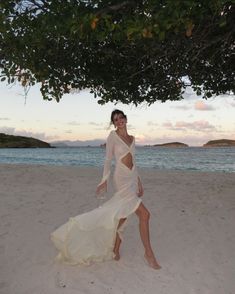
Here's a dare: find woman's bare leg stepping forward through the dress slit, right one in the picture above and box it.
[135,203,161,269]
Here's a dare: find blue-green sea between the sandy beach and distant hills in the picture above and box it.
[0,147,235,172]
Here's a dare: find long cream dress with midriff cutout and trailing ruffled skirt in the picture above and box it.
[51,131,141,265]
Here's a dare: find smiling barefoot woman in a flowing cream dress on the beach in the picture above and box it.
[51,109,161,269]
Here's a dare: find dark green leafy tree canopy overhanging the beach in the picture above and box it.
[0,0,235,105]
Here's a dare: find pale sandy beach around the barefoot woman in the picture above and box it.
[0,164,235,294]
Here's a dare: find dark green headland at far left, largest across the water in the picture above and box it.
[0,133,51,148]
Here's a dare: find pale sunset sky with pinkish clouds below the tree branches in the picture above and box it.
[0,82,235,146]
